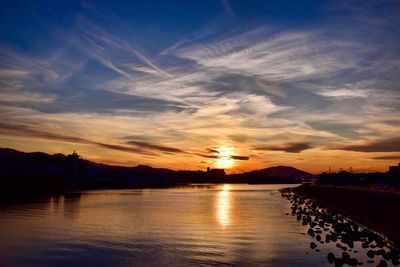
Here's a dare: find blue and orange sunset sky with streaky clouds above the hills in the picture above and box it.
[0,0,400,173]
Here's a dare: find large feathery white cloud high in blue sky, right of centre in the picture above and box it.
[176,28,360,81]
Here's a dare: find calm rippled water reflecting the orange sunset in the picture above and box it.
[0,185,364,266]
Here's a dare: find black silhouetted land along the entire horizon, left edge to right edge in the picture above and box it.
[0,148,400,198]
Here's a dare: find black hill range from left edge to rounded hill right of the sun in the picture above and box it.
[0,148,314,192]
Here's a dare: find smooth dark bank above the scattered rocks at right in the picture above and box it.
[293,185,400,243]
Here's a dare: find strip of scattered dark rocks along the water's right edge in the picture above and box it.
[281,188,400,267]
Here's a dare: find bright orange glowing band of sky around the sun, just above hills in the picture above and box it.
[0,135,398,174]
